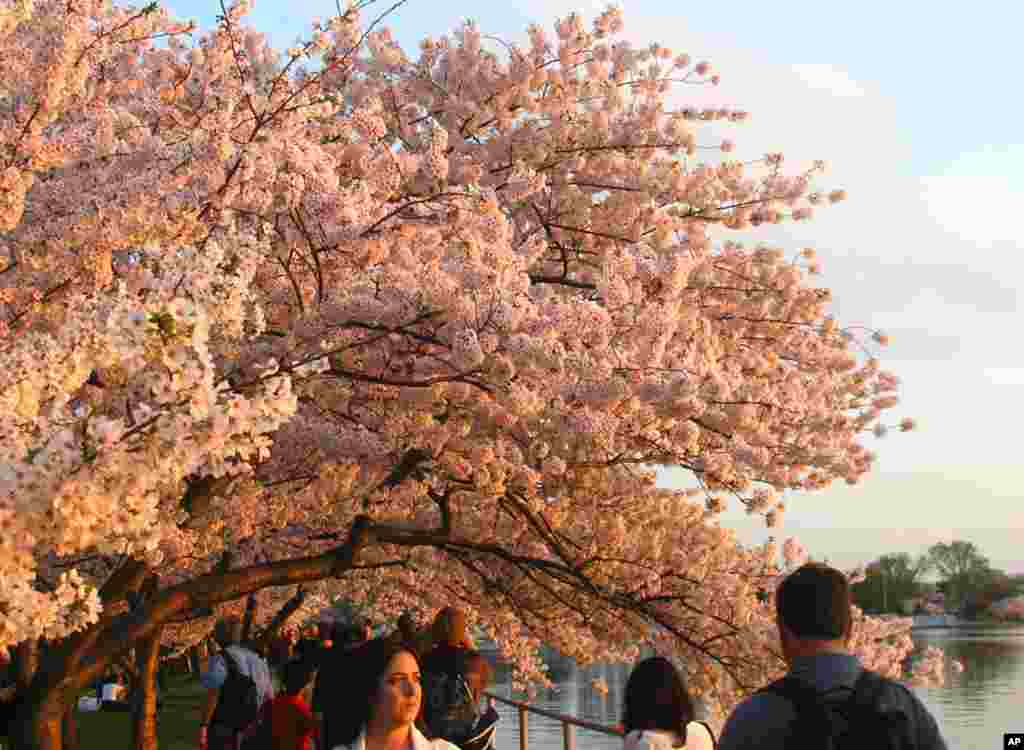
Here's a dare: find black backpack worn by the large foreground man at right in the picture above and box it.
[762,669,914,750]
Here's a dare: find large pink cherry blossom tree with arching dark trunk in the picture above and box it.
[0,0,937,750]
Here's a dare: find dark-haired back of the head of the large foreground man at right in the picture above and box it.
[775,563,853,662]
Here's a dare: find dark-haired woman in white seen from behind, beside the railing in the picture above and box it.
[623,657,715,750]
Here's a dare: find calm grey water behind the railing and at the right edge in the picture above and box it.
[495,626,1024,750]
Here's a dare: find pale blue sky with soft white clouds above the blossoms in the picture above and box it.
[163,0,1024,573]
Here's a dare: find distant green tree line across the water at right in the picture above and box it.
[852,540,1024,618]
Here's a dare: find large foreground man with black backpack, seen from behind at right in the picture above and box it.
[719,563,946,750]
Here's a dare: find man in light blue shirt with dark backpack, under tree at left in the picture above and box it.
[200,617,273,750]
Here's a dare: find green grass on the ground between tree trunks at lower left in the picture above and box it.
[75,675,206,750]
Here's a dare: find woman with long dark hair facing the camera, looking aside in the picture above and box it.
[327,638,459,750]
